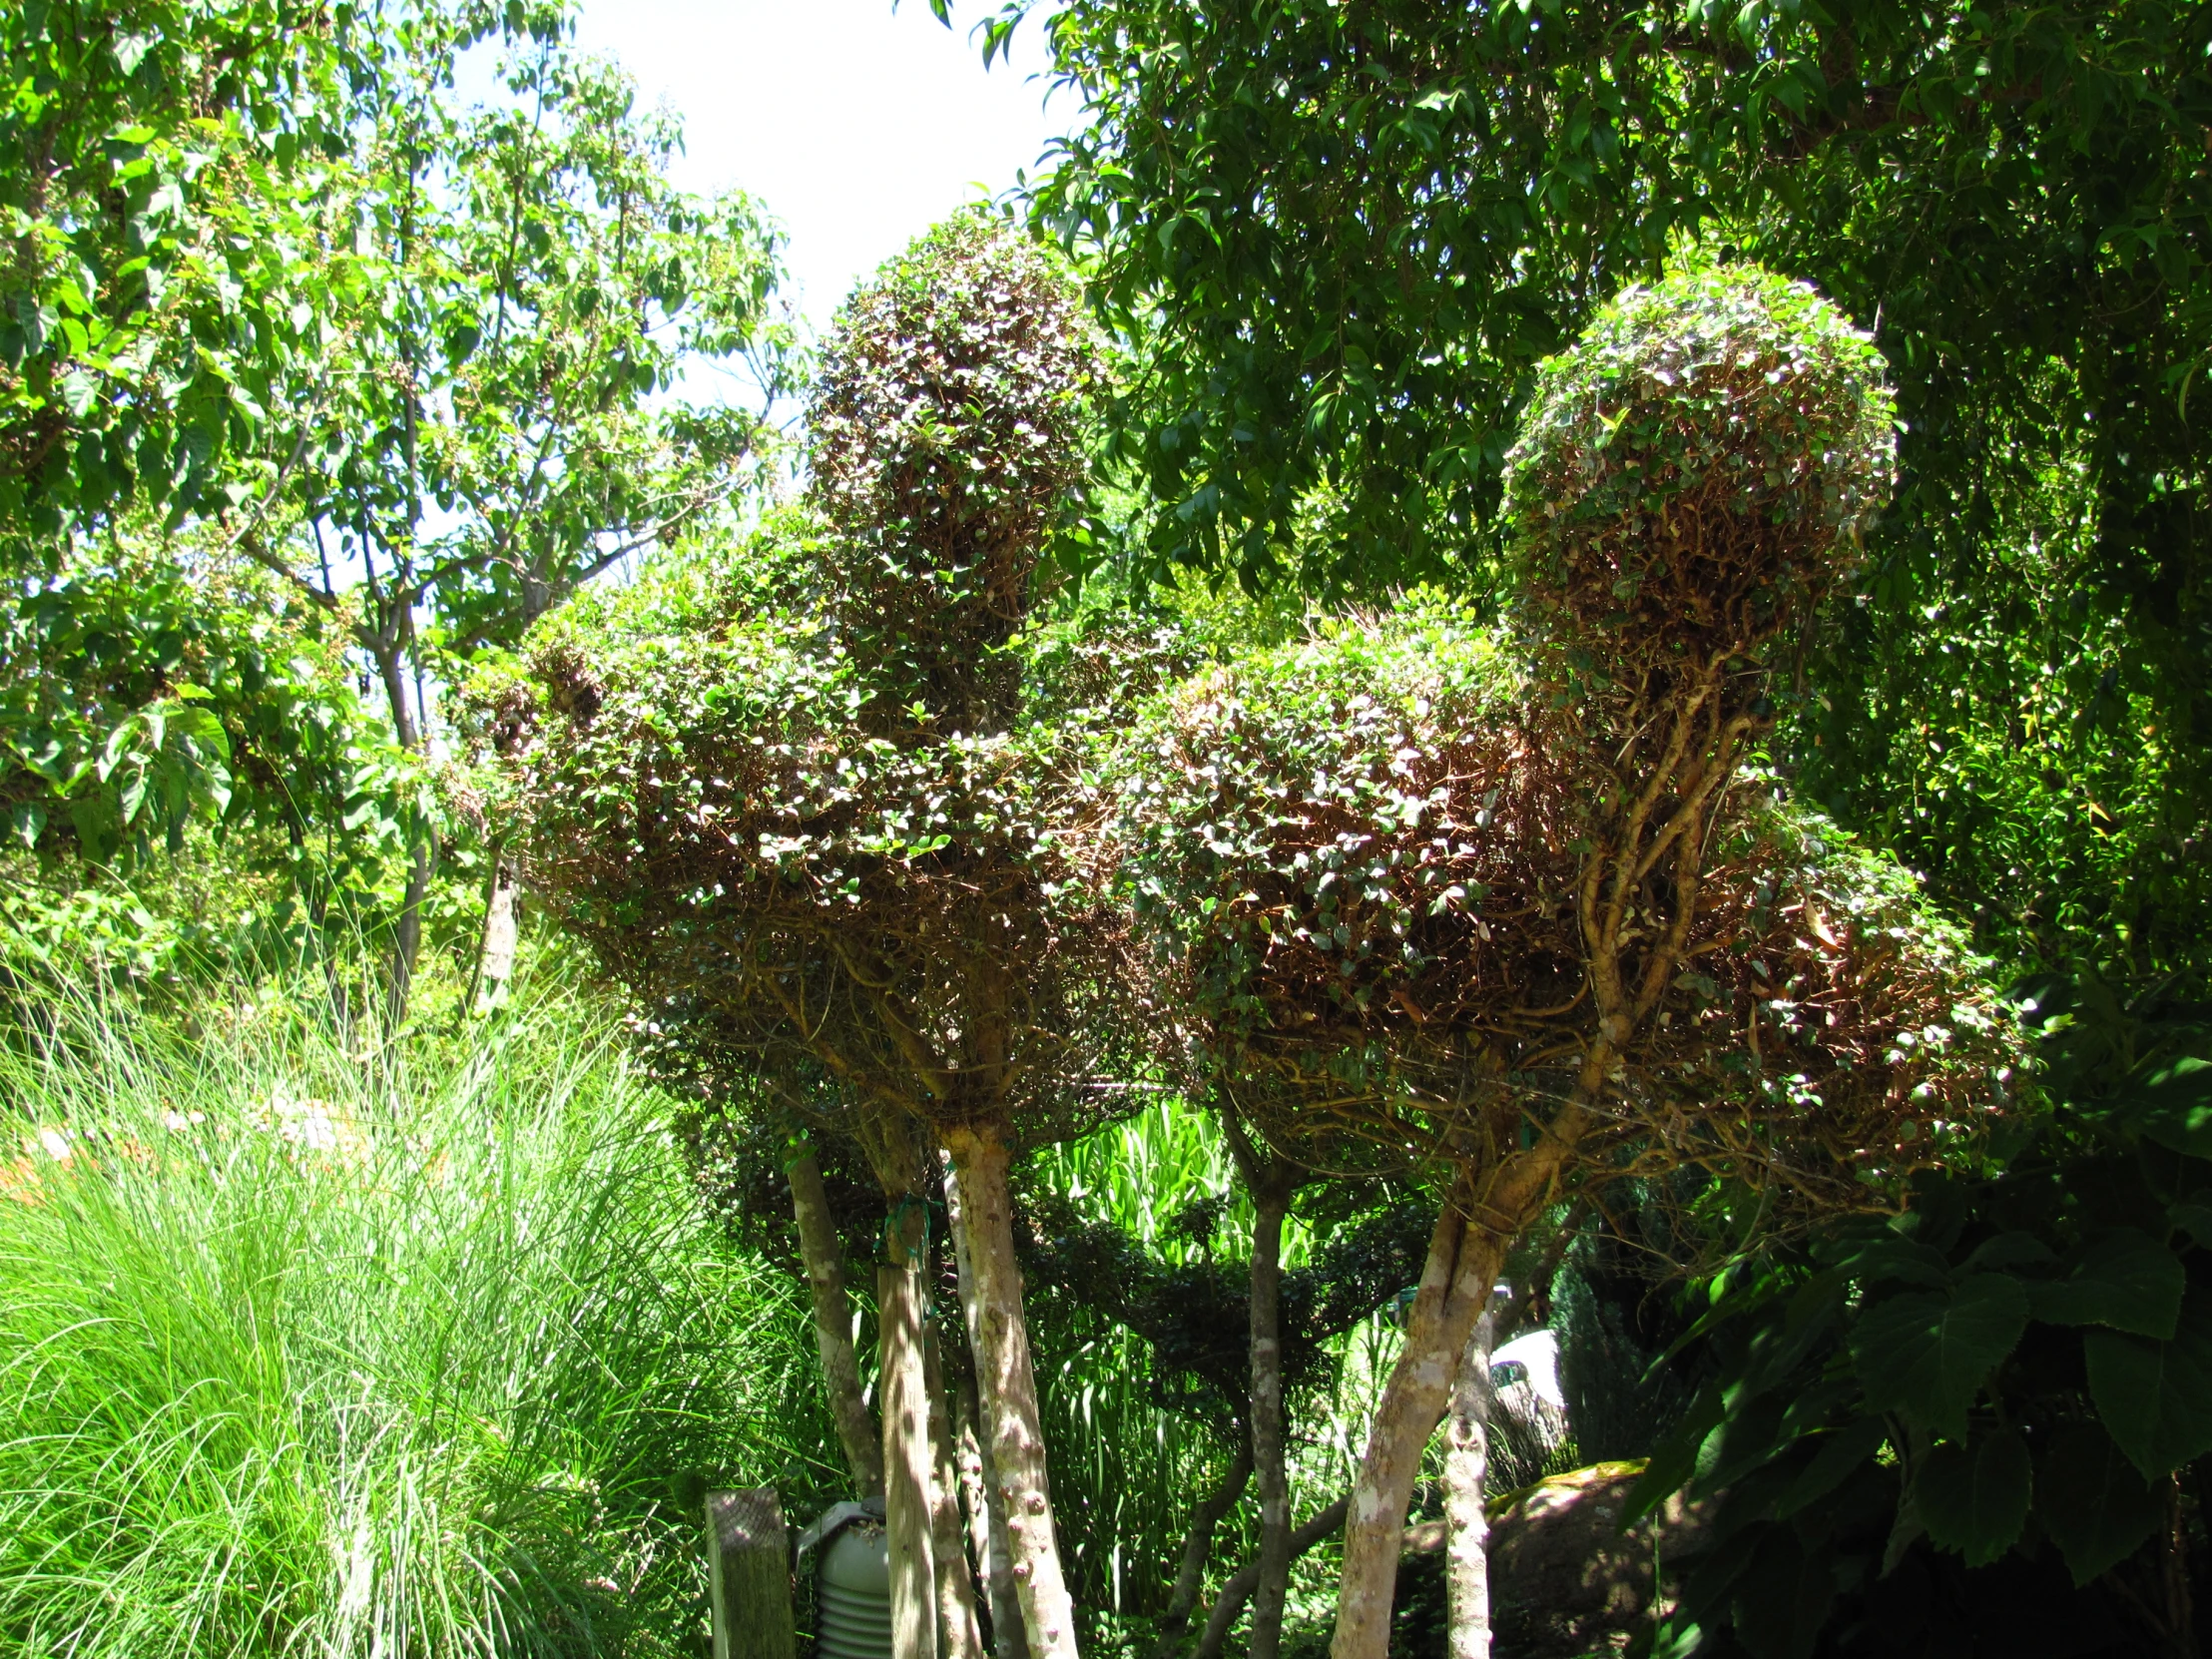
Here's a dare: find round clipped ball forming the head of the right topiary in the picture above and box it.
[1506,266,1896,668]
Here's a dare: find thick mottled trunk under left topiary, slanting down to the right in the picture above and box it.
[946,1128,1075,1659]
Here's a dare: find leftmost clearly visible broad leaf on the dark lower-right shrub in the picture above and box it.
[1852,1274,2028,1440]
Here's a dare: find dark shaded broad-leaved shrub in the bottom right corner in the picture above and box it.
[1639,986,2212,1655]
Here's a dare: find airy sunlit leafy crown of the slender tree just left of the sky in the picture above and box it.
[244,26,790,657]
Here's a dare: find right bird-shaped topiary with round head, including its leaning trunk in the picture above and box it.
[1115,268,2010,1659]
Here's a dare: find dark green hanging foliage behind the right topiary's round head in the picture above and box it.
[977,0,2212,1026]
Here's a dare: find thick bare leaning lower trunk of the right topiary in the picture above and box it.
[1330,1204,1504,1659]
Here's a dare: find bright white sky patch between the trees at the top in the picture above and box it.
[577,0,1079,331]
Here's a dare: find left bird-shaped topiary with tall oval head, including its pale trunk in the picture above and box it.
[475,219,1126,1659]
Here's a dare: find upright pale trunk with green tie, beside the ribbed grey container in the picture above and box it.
[876,1199,938,1659]
